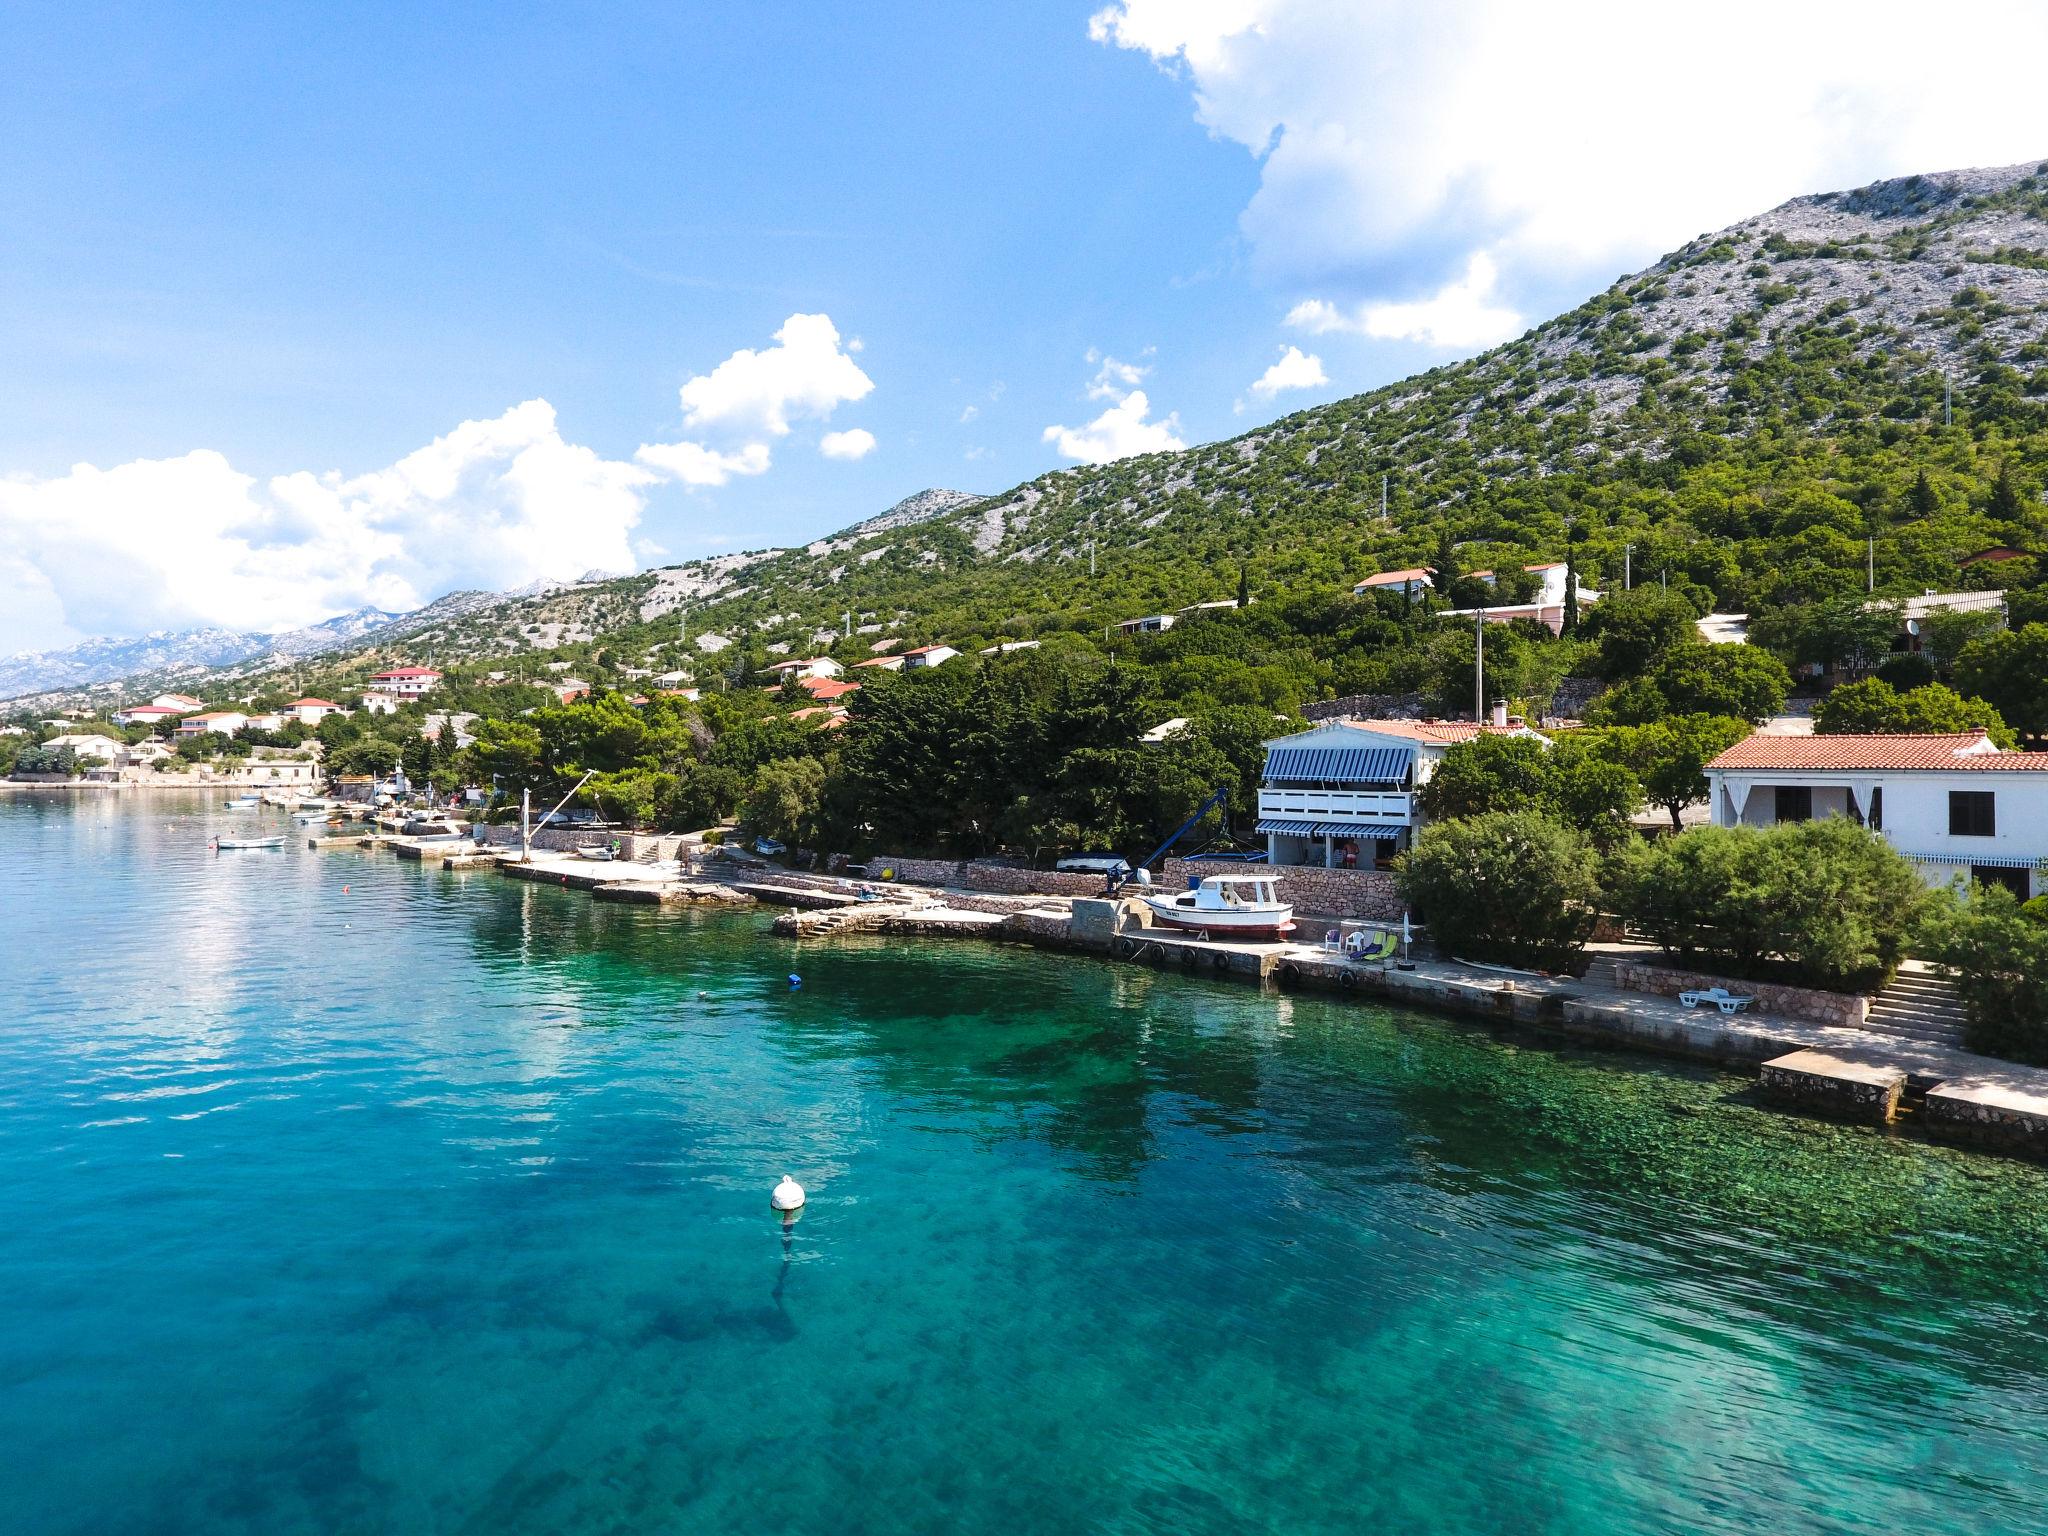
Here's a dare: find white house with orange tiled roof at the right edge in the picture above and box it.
[1706,731,2048,897]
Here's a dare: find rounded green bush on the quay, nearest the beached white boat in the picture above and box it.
[1395,811,1599,971]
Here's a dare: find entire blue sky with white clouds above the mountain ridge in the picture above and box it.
[0,0,2048,649]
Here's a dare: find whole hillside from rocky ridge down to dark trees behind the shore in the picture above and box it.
[24,166,2048,868]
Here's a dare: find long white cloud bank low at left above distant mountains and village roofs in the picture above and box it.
[0,399,655,647]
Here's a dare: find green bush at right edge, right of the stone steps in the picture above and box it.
[1919,885,2048,1065]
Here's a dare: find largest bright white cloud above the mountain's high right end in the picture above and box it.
[1090,0,2048,346]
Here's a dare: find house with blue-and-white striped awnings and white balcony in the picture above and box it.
[1257,719,1550,868]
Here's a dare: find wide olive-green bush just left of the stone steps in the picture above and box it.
[1610,817,1927,991]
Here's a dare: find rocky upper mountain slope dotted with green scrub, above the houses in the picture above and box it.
[16,153,2048,708]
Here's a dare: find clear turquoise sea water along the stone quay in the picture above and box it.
[0,795,2048,1536]
